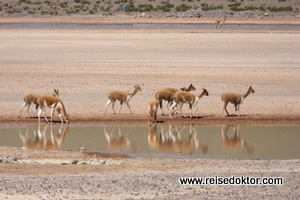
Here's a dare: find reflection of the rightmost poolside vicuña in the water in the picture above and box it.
[222,125,253,155]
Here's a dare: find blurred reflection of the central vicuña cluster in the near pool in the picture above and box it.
[148,124,208,154]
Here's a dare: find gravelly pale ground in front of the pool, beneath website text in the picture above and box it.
[0,147,300,199]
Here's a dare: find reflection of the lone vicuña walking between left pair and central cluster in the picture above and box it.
[103,127,139,154]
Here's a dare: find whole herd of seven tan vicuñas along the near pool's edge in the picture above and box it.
[19,84,255,123]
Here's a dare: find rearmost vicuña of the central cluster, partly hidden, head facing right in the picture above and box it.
[155,84,196,115]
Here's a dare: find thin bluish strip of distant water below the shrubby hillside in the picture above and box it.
[0,23,300,29]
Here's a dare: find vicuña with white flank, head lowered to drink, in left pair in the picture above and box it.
[37,95,69,123]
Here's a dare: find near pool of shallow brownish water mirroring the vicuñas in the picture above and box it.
[0,125,300,159]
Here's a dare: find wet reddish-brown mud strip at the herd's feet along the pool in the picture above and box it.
[0,115,300,126]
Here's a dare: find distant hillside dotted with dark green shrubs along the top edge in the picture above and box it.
[0,0,300,18]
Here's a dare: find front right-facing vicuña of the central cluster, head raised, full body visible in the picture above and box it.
[170,88,209,118]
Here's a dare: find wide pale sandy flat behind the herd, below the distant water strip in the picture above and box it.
[0,18,300,123]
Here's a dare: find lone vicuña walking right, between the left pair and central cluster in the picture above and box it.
[104,85,142,115]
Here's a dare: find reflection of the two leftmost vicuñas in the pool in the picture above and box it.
[19,124,70,149]
